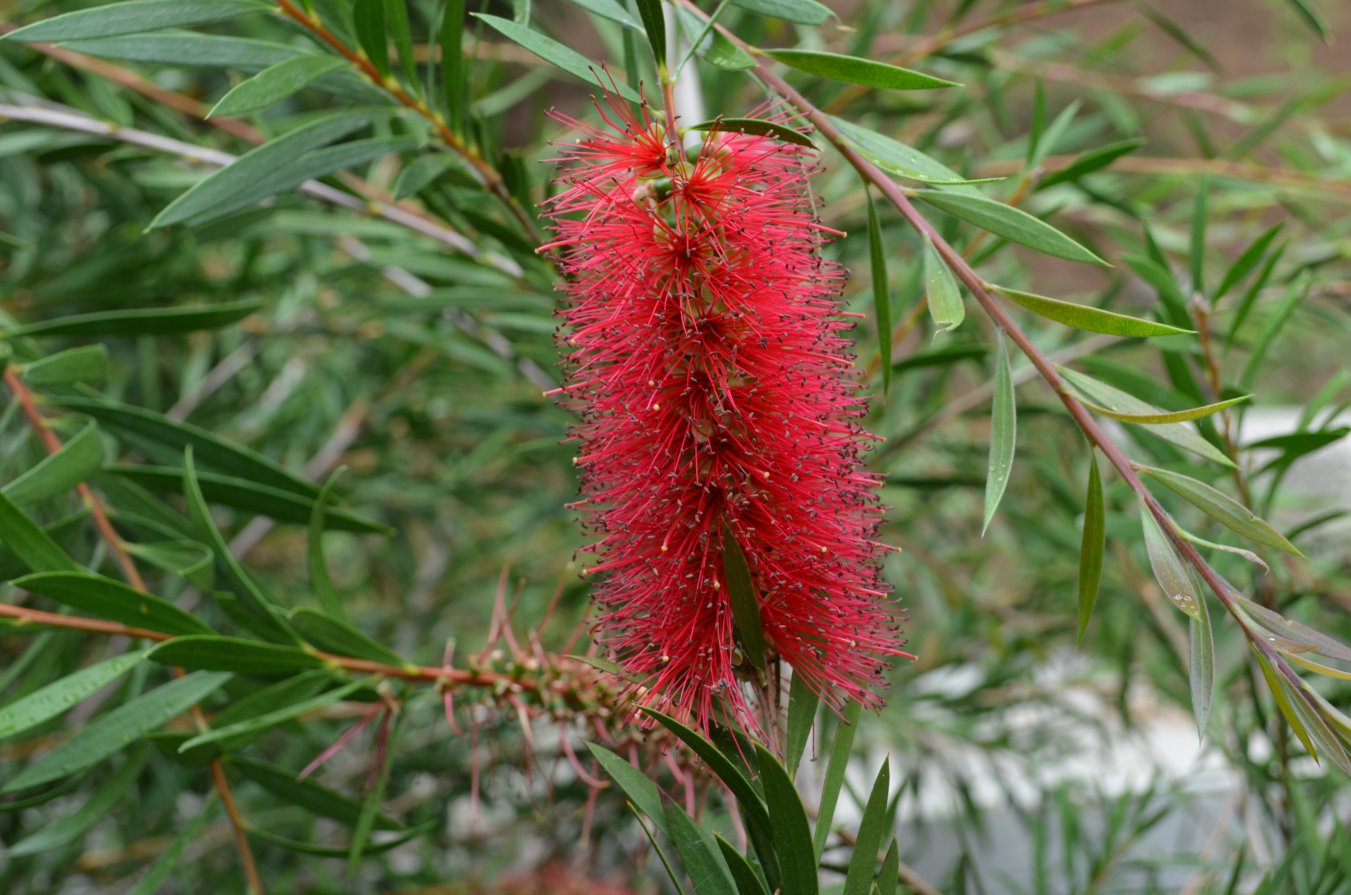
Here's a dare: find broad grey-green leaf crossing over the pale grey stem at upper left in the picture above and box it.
[149,110,388,230]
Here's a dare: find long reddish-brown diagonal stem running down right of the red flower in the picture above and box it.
[681,0,1288,669]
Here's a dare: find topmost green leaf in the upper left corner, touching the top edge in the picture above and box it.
[4,0,270,43]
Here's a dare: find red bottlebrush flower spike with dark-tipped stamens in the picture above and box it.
[547,101,901,729]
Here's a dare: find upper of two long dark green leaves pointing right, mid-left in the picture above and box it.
[58,395,319,505]
